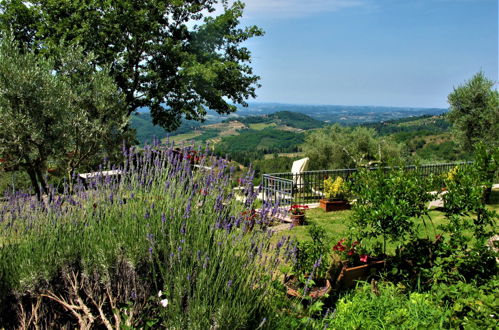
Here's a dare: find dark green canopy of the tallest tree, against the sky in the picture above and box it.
[0,0,263,130]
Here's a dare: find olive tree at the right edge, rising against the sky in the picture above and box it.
[447,72,499,149]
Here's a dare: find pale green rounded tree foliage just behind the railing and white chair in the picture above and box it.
[301,124,401,169]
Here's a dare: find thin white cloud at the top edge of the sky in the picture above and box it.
[244,0,368,18]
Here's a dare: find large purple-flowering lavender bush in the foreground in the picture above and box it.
[0,145,289,329]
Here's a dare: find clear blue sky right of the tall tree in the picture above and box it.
[237,0,498,107]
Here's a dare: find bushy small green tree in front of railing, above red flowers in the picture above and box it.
[350,168,432,253]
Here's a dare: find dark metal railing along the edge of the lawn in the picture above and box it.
[262,162,472,206]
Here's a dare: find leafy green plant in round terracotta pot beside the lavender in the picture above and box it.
[284,225,331,299]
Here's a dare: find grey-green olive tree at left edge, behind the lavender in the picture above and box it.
[0,38,127,196]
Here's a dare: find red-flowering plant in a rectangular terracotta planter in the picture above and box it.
[329,238,385,288]
